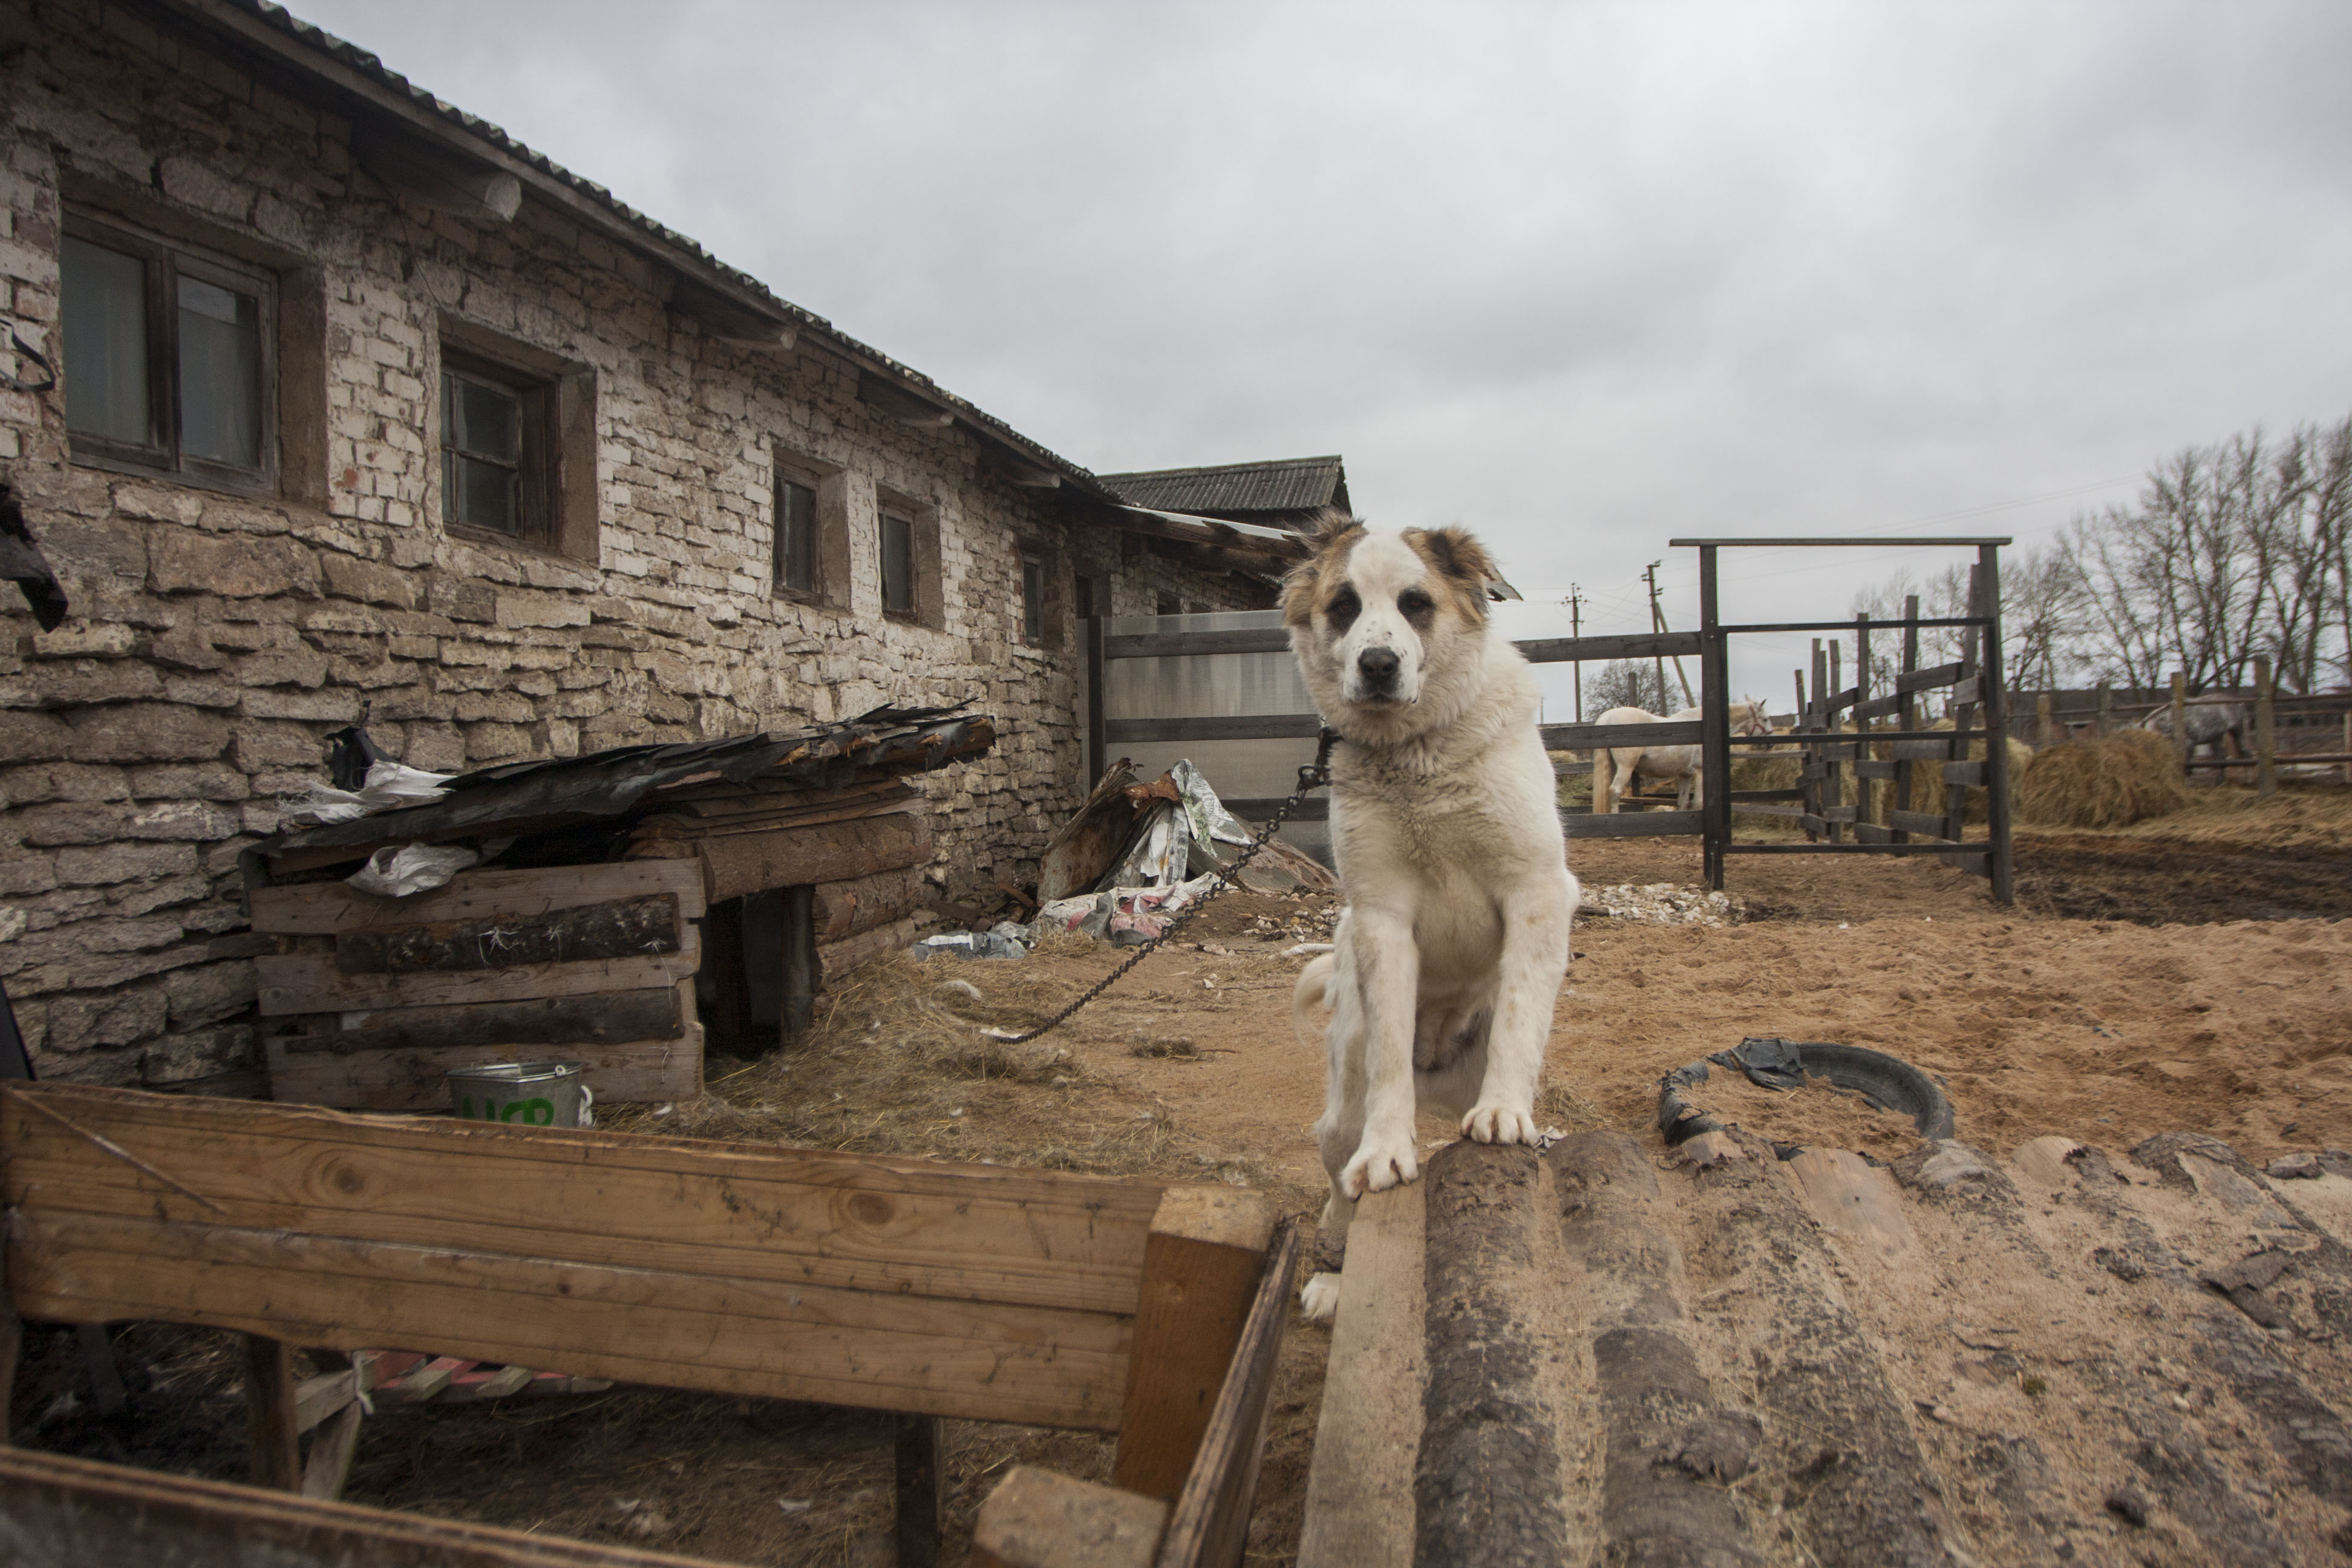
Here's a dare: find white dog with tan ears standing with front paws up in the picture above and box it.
[1282,515,1578,1316]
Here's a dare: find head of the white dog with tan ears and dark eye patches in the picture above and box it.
[1282,512,1496,738]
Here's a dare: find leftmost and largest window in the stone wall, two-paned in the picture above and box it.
[59,214,278,494]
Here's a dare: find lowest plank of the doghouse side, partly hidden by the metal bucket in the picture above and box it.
[261,1025,704,1109]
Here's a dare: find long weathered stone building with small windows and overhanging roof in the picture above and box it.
[0,0,1307,1083]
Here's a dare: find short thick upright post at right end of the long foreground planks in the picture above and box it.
[1110,1187,1275,1500]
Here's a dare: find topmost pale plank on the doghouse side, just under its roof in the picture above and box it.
[252,860,704,936]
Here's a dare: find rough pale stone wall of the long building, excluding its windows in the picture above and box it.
[0,0,1249,1083]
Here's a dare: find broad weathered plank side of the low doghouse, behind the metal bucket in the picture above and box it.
[252,860,705,1109]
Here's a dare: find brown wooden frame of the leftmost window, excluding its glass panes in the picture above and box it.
[56,207,278,496]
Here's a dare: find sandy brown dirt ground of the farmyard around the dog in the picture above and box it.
[16,788,2352,1566]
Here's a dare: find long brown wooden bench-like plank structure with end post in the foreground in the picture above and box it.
[0,1083,1298,1568]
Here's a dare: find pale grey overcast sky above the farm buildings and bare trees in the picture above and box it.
[294,0,2352,717]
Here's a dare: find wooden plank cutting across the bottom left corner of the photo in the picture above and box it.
[0,1448,743,1568]
